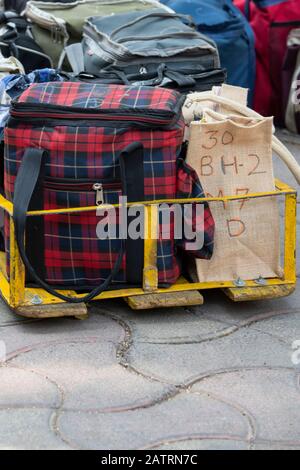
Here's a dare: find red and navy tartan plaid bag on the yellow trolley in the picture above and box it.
[5,82,214,301]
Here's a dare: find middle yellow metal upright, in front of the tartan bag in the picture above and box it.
[143,206,158,293]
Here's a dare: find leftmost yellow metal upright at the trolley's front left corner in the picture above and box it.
[9,217,25,308]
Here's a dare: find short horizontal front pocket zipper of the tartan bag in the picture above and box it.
[44,178,122,206]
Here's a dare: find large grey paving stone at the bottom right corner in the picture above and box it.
[192,369,300,443]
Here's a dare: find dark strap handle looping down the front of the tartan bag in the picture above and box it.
[13,143,142,304]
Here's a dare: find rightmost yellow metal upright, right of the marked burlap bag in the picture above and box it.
[284,194,297,283]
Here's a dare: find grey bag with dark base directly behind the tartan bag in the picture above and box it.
[83,8,225,92]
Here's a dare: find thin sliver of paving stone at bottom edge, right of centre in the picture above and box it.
[153,438,249,451]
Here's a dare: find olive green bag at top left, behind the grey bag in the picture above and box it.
[25,0,169,67]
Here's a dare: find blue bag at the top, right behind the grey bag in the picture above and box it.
[161,0,255,100]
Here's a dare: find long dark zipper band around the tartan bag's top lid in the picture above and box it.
[10,101,180,125]
